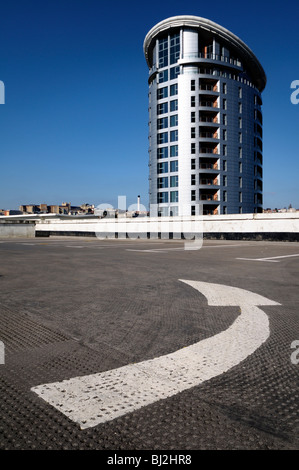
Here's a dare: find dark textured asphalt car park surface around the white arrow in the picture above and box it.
[0,237,299,451]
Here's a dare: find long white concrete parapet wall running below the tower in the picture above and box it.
[36,212,299,241]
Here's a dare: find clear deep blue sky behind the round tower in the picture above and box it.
[0,0,299,209]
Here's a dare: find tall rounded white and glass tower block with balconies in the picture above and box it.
[144,16,266,216]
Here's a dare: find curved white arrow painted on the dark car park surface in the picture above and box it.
[31,280,280,429]
